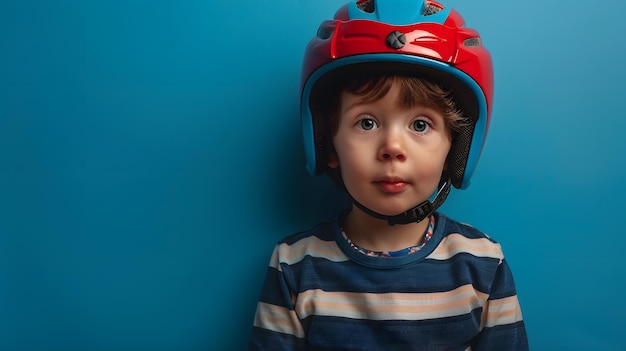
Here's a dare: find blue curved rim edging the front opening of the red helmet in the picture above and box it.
[300,54,487,189]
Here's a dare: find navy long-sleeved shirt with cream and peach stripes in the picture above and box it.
[249,213,528,351]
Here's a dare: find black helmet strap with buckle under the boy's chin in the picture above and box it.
[346,179,452,225]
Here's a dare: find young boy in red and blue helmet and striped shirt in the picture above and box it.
[249,0,528,351]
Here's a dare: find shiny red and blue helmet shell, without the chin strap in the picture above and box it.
[300,0,493,189]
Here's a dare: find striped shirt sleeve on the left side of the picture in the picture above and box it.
[248,246,307,351]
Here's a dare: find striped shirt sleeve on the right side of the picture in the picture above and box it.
[471,260,528,351]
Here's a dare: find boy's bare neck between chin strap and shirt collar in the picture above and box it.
[343,206,428,251]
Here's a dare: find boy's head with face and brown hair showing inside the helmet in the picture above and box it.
[323,76,463,220]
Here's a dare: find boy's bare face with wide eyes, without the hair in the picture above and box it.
[328,83,451,216]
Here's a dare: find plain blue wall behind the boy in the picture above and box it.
[0,0,626,351]
